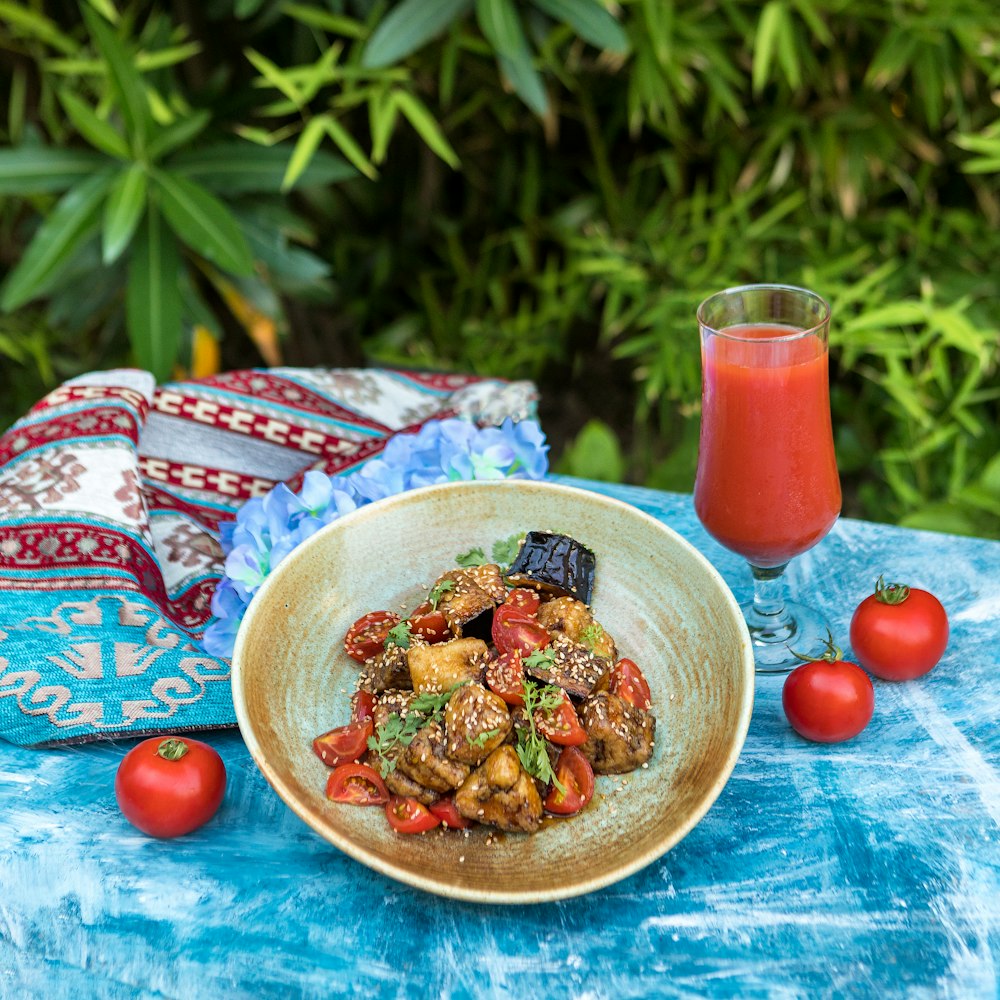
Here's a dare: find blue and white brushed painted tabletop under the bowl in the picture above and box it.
[0,483,1000,1000]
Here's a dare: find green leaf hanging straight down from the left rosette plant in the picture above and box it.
[125,205,181,381]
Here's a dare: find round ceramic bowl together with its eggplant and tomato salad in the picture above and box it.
[232,480,754,903]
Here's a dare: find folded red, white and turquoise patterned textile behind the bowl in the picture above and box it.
[0,368,535,746]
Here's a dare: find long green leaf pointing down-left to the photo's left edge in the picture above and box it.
[0,170,113,312]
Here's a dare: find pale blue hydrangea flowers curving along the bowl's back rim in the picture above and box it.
[202,418,549,657]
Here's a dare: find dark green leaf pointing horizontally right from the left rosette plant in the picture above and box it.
[170,142,358,195]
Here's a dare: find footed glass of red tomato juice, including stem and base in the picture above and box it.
[694,285,840,672]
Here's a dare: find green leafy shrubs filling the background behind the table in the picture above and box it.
[0,0,1000,537]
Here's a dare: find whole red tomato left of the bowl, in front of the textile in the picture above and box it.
[115,736,226,837]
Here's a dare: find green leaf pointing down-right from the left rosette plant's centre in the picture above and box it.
[153,170,253,275]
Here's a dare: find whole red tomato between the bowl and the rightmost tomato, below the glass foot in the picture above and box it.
[781,641,875,743]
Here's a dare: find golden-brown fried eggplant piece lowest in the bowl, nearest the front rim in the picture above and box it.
[455,745,542,833]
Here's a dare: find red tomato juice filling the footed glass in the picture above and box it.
[694,324,840,567]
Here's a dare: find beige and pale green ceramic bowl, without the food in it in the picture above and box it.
[232,481,754,903]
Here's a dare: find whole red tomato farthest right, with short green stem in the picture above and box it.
[851,577,948,681]
